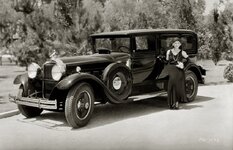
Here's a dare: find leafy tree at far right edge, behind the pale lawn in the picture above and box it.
[209,1,233,64]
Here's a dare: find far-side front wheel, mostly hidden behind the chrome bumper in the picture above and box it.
[18,86,43,118]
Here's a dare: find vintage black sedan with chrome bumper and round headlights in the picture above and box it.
[10,29,205,128]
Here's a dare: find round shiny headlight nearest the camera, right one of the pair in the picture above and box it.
[52,63,66,81]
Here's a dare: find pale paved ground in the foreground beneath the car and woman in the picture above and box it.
[0,84,233,150]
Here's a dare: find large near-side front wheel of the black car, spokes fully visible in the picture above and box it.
[65,82,95,128]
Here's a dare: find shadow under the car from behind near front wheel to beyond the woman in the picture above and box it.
[84,96,213,129]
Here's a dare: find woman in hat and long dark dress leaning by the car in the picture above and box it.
[166,39,188,109]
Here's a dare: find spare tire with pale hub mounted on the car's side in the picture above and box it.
[103,63,133,101]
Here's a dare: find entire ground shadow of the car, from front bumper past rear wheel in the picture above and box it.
[21,96,213,131]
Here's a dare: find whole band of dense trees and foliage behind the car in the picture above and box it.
[0,0,233,65]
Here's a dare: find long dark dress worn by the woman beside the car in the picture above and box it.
[165,51,187,108]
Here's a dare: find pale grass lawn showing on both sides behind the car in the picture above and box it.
[0,60,230,113]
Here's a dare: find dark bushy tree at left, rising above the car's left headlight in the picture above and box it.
[12,0,53,66]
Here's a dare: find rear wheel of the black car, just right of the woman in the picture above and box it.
[185,71,198,102]
